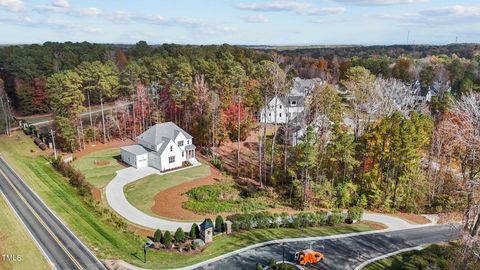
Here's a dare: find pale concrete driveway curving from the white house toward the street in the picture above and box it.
[105,166,431,231]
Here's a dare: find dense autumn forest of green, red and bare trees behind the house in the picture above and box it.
[0,42,480,266]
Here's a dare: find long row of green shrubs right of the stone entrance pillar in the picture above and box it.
[227,211,345,231]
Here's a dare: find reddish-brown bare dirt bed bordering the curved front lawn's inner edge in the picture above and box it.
[152,167,222,220]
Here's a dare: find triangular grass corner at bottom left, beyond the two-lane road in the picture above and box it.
[0,196,51,270]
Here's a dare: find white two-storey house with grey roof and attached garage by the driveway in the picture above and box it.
[120,122,198,171]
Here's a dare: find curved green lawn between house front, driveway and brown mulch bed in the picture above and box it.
[124,164,211,215]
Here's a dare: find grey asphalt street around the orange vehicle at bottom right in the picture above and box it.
[197,225,459,270]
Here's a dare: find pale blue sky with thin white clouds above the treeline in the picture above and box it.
[0,0,480,45]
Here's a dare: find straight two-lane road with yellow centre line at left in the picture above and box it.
[0,157,105,270]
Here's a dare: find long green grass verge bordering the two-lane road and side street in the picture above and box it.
[0,132,378,269]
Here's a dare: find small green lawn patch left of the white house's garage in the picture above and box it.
[73,148,124,189]
